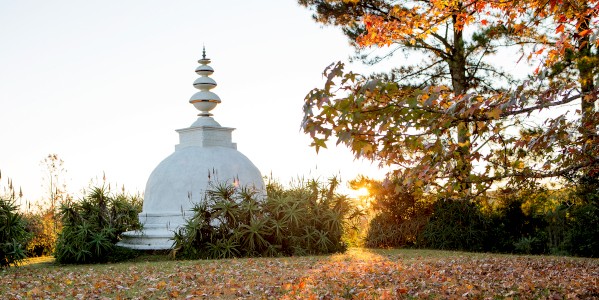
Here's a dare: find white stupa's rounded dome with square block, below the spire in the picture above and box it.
[142,122,264,217]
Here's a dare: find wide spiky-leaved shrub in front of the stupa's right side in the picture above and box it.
[174,179,349,258]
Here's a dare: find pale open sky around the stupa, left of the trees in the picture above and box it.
[0,0,385,200]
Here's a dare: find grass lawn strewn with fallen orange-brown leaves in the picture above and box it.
[0,248,599,299]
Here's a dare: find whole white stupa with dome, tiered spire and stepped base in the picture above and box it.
[117,49,264,250]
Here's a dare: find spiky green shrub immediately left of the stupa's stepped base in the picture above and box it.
[55,186,141,263]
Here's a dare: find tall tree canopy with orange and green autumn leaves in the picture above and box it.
[299,0,598,198]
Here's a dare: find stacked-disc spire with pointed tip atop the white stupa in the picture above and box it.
[189,48,221,117]
